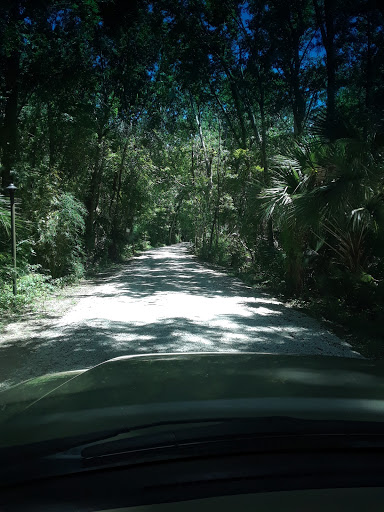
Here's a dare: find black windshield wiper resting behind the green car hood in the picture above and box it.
[80,417,384,465]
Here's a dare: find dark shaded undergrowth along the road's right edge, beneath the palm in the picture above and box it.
[196,235,384,359]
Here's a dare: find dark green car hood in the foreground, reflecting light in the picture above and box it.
[0,353,384,447]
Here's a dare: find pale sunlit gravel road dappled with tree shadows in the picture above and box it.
[0,244,361,389]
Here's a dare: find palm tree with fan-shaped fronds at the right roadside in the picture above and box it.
[259,130,384,292]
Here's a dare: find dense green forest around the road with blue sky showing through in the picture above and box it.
[0,0,384,326]
